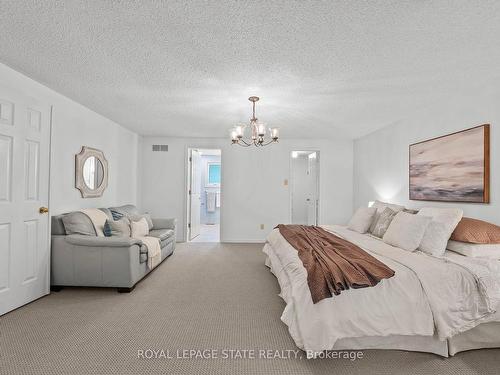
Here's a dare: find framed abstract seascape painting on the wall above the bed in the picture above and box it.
[410,125,489,203]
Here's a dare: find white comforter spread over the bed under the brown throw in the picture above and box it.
[264,226,500,351]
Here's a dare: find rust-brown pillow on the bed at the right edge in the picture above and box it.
[451,217,500,244]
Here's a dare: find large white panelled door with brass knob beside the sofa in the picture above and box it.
[0,87,51,315]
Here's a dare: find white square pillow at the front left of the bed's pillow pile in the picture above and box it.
[383,212,432,251]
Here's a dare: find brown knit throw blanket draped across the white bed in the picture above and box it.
[277,224,394,303]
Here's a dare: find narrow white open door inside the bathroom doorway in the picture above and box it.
[189,150,201,240]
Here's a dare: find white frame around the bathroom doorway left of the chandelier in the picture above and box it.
[182,146,224,242]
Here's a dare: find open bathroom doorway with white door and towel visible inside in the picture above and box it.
[187,148,222,242]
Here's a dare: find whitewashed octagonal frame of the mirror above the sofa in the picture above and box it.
[75,146,108,198]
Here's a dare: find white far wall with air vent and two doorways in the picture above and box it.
[141,137,353,242]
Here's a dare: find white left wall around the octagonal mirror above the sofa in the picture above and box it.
[0,64,139,215]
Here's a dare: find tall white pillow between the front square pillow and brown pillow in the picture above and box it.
[417,207,463,257]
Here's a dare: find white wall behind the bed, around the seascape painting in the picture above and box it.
[354,89,500,224]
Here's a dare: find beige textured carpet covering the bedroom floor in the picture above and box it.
[0,243,500,375]
